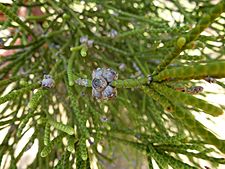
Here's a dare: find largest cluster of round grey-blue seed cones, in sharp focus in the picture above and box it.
[92,68,118,100]
